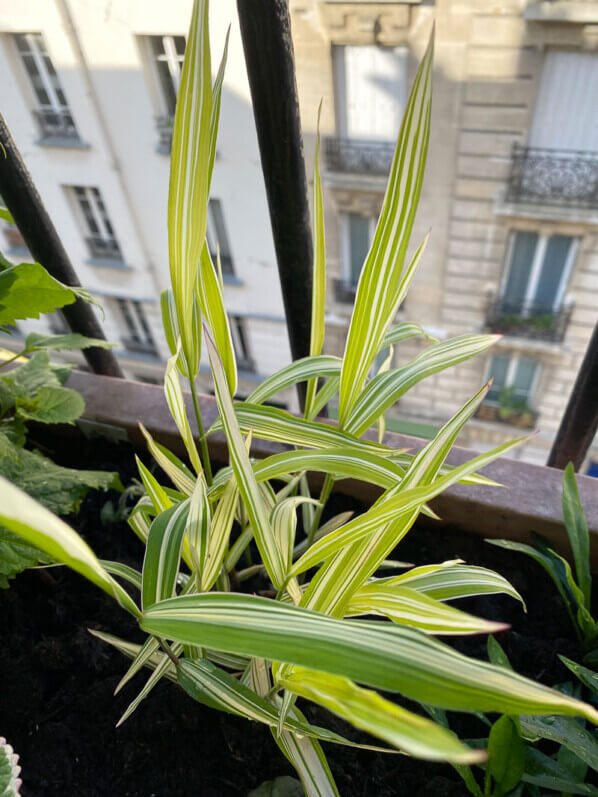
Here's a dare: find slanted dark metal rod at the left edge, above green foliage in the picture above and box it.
[0,114,124,377]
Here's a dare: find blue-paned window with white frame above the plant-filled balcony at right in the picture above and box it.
[501,231,576,316]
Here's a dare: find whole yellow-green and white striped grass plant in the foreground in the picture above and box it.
[0,0,598,795]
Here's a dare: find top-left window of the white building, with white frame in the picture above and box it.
[14,33,79,139]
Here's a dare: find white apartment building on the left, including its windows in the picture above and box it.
[0,0,294,400]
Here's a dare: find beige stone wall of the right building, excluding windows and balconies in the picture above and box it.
[291,0,598,463]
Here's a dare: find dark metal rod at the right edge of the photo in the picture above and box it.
[546,323,598,471]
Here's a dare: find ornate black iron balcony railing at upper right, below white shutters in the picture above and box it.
[505,144,598,208]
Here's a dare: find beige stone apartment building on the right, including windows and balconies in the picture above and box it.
[290,0,598,470]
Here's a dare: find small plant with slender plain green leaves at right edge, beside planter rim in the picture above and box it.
[494,463,598,666]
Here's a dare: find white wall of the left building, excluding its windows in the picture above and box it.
[0,0,294,402]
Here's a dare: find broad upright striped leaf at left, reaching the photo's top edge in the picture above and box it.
[168,0,213,361]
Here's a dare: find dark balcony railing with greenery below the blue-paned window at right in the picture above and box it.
[486,298,573,343]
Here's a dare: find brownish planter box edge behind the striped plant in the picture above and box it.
[68,371,598,571]
